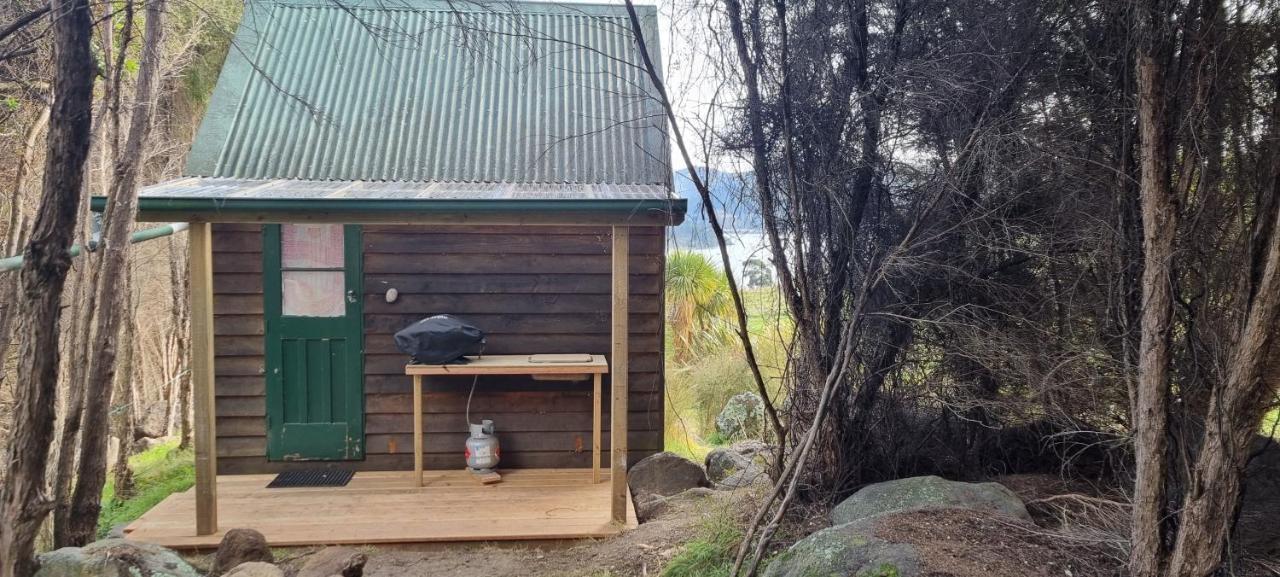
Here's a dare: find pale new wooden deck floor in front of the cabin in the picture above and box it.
[124,470,636,549]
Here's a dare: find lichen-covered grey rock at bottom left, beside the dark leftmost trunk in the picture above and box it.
[35,539,200,577]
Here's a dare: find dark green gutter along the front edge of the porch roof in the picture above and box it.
[91,196,689,226]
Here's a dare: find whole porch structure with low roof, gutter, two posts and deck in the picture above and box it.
[95,178,685,549]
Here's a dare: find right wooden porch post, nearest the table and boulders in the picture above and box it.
[609,226,631,525]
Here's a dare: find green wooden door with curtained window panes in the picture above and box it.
[262,224,365,461]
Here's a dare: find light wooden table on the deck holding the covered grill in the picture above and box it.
[404,354,609,486]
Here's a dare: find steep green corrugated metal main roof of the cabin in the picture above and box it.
[187,0,671,192]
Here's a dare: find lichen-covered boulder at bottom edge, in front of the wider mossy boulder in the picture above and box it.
[764,518,923,577]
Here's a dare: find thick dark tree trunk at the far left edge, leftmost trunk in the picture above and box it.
[0,0,93,577]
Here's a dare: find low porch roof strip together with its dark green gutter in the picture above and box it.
[90,177,687,226]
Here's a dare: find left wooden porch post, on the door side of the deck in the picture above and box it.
[188,223,218,535]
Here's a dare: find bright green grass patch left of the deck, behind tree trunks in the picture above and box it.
[97,440,196,537]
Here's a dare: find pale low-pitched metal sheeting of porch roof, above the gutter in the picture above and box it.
[140,178,675,202]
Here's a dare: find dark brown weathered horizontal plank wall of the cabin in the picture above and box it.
[214,225,664,473]
